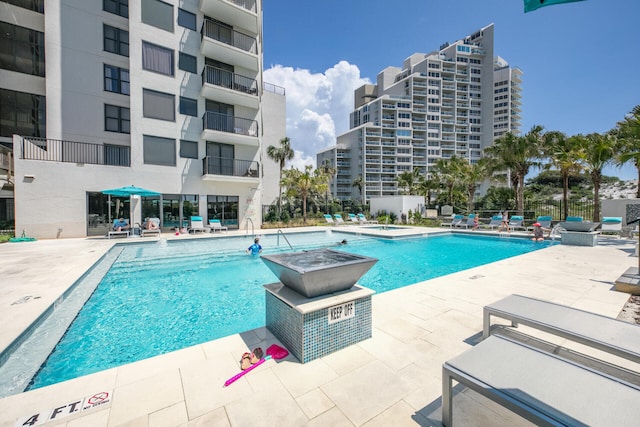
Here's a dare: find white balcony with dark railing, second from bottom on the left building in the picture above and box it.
[202,111,259,147]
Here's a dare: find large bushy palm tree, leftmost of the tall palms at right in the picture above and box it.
[485,125,543,215]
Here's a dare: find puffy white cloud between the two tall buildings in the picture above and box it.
[264,61,370,169]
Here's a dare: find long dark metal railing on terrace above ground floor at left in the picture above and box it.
[21,138,131,167]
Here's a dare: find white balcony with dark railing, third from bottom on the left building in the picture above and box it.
[200,65,260,110]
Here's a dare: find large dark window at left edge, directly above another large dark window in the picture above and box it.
[0,22,45,77]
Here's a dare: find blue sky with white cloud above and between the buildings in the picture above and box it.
[263,0,640,179]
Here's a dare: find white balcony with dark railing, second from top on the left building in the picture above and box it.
[200,19,259,72]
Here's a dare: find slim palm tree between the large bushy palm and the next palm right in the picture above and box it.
[543,131,582,219]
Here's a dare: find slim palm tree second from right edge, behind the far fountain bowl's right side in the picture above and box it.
[575,133,616,221]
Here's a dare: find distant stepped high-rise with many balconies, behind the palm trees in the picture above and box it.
[317,24,522,201]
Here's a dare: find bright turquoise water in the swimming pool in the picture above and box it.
[29,232,549,389]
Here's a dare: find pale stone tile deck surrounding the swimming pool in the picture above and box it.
[0,226,638,427]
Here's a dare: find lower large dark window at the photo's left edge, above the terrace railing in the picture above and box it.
[0,89,46,138]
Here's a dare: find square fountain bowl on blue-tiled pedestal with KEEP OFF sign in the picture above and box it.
[261,249,378,363]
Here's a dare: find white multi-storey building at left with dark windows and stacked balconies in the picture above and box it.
[0,0,285,238]
